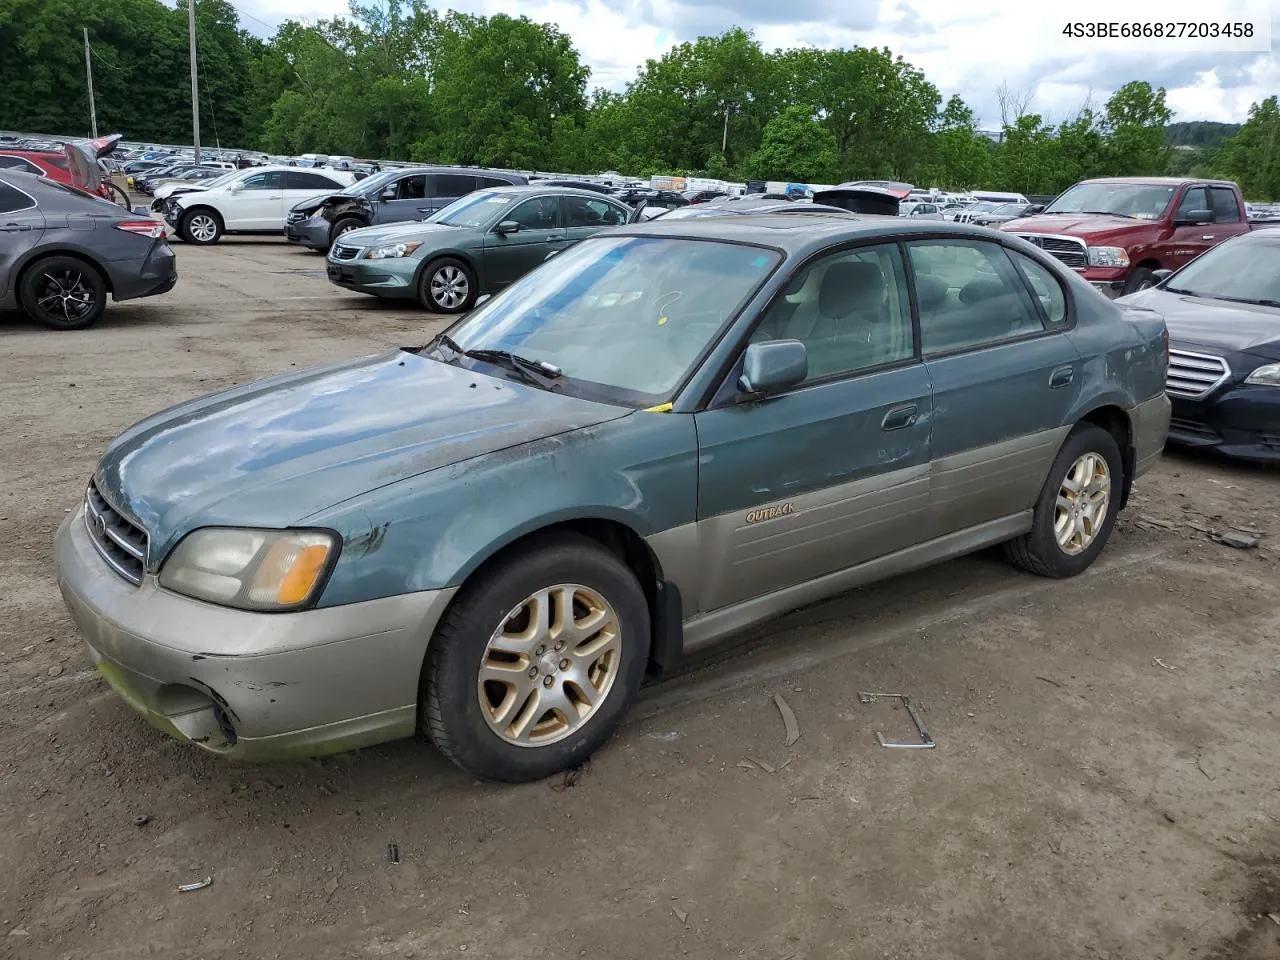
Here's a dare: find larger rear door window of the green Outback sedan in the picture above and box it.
[908,239,1044,356]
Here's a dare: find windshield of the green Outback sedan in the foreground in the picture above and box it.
[440,237,782,408]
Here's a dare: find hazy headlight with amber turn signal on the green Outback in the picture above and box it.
[160,527,337,611]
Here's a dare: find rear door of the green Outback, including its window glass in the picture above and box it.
[908,238,1084,535]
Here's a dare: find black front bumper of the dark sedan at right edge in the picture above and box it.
[1169,384,1280,463]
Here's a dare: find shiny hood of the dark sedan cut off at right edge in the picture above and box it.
[1116,288,1280,360]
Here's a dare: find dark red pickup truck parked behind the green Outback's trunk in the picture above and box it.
[1001,177,1251,297]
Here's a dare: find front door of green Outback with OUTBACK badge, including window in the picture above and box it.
[695,244,933,612]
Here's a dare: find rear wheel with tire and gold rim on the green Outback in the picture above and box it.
[1005,424,1124,577]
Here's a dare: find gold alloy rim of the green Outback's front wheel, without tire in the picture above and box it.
[476,584,622,746]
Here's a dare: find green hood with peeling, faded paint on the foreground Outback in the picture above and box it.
[96,351,630,561]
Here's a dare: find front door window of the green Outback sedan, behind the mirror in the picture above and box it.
[750,243,915,380]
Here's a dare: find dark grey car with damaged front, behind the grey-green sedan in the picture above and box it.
[284,166,527,252]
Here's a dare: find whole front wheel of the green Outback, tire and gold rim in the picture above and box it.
[421,532,649,783]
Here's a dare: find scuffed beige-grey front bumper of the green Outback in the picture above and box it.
[55,507,453,760]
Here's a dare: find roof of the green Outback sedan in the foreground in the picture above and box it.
[609,211,1018,256]
